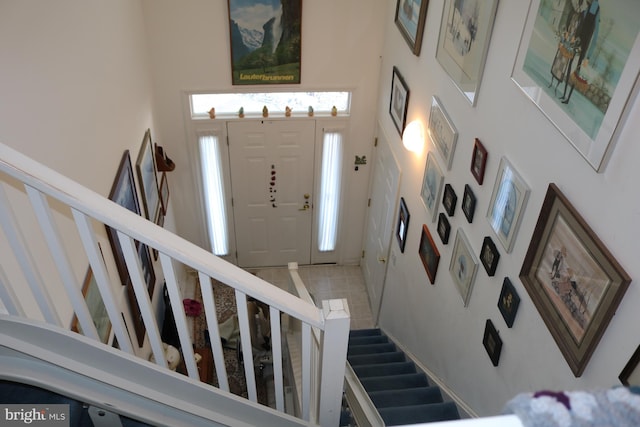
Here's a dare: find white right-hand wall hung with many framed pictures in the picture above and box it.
[378,0,640,415]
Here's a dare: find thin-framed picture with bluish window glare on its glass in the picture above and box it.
[487,157,529,253]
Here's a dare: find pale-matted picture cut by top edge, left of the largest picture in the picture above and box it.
[436,0,498,105]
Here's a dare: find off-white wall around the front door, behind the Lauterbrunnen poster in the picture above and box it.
[143,0,385,263]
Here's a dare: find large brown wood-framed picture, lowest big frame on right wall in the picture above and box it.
[520,184,631,377]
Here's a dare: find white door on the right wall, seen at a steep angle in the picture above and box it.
[362,131,400,322]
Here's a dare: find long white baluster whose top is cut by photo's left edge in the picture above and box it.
[0,185,62,326]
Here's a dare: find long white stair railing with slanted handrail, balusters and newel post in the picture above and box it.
[0,144,349,426]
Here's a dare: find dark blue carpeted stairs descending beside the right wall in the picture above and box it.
[347,329,460,426]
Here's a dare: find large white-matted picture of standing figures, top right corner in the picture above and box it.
[511,0,640,172]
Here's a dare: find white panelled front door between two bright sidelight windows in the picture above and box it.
[227,120,315,267]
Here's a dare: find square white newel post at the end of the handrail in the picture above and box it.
[318,299,350,427]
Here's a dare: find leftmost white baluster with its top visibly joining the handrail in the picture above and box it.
[25,185,100,341]
